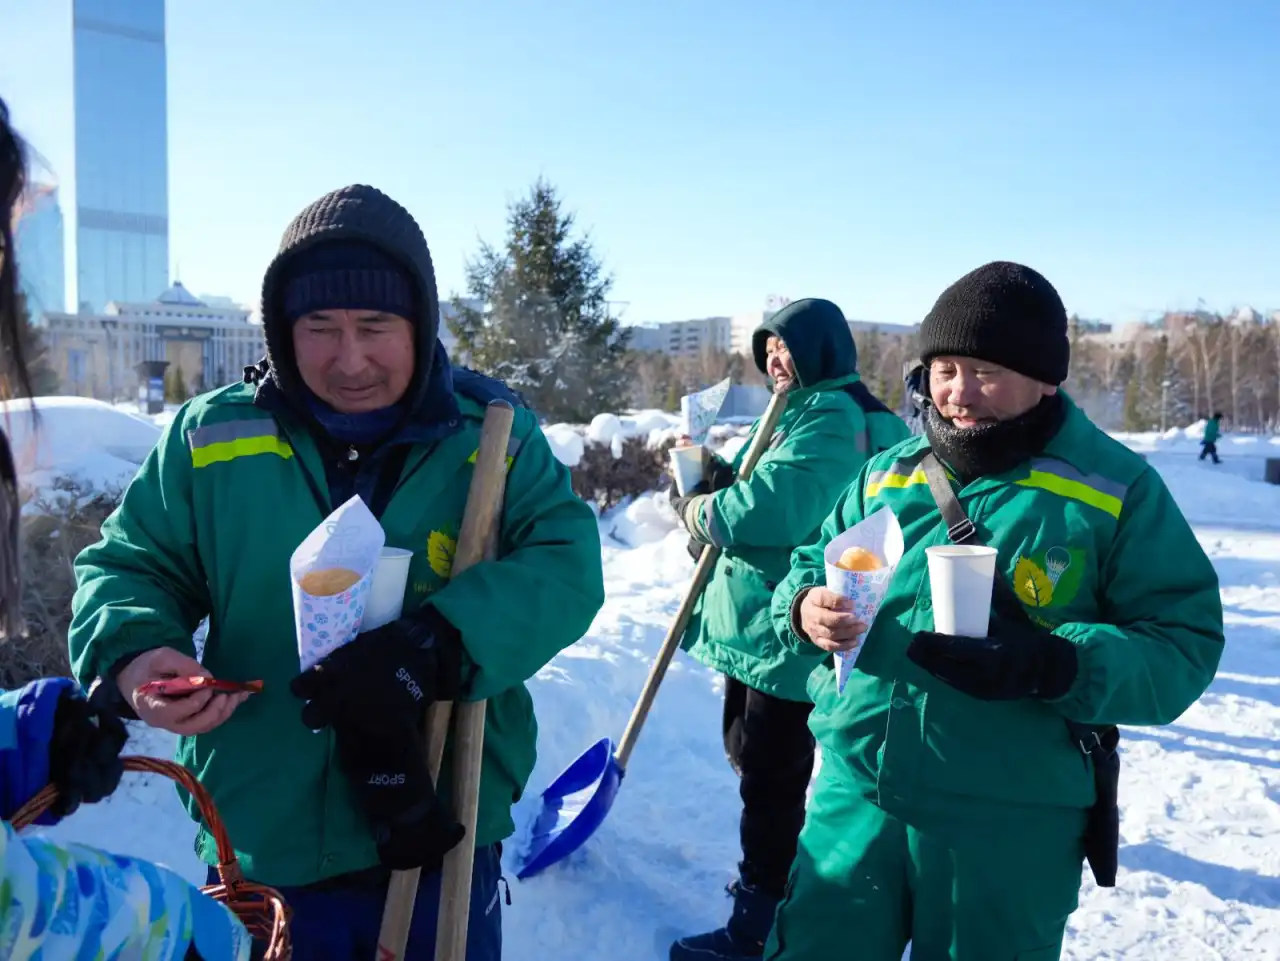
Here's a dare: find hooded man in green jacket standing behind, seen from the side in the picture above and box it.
[671,299,908,961]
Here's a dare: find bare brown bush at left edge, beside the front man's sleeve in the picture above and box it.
[0,477,123,688]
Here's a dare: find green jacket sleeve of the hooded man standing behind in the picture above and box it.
[703,392,867,548]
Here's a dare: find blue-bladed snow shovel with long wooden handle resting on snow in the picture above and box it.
[516,393,787,880]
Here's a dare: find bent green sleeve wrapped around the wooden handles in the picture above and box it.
[431,411,604,700]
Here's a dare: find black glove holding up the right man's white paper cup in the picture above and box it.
[906,622,1078,701]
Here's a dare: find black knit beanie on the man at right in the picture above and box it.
[920,261,1071,385]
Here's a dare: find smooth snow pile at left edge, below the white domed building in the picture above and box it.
[0,397,160,490]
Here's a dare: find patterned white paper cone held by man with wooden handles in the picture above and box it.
[289,495,387,671]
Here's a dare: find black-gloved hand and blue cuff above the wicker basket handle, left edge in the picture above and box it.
[0,677,128,825]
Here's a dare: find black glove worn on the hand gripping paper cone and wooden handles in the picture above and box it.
[289,607,462,731]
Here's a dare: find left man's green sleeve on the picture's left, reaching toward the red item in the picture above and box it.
[67,407,211,685]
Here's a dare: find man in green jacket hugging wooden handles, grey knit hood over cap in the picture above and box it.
[69,186,604,961]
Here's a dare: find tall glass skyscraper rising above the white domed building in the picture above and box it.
[72,0,169,311]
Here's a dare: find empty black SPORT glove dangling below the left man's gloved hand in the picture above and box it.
[333,715,466,874]
